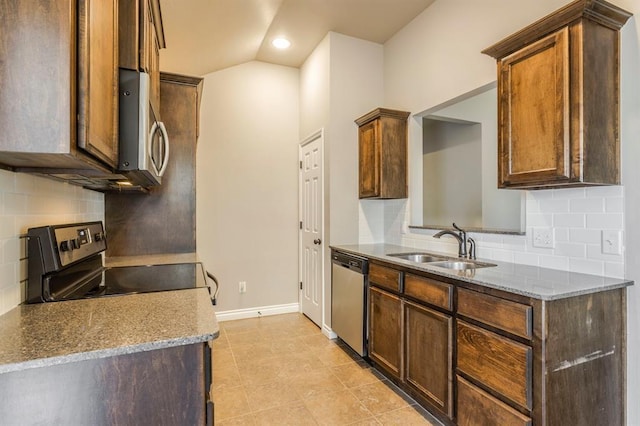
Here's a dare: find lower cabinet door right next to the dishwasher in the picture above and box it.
[369,287,402,380]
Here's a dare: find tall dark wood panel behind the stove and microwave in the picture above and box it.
[104,73,204,257]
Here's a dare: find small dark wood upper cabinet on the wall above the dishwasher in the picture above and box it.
[356,108,409,198]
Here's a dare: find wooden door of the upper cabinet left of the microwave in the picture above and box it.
[77,0,118,167]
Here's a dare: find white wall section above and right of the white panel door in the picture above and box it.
[300,32,384,328]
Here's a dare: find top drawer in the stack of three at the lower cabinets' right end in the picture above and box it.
[458,288,533,339]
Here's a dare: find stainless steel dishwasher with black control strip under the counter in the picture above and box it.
[331,251,369,356]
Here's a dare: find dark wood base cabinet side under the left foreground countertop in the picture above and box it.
[0,343,213,425]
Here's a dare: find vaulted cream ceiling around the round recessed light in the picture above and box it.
[160,0,435,76]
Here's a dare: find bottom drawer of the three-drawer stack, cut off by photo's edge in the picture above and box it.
[456,376,532,426]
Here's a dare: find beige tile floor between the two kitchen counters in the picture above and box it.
[213,314,438,426]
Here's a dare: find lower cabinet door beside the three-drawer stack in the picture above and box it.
[404,302,453,418]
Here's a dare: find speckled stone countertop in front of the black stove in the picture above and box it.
[0,288,219,373]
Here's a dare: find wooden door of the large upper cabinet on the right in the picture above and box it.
[498,27,571,187]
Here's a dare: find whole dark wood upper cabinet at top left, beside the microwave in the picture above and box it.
[0,0,118,175]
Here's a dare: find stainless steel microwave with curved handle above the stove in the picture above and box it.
[118,68,169,187]
